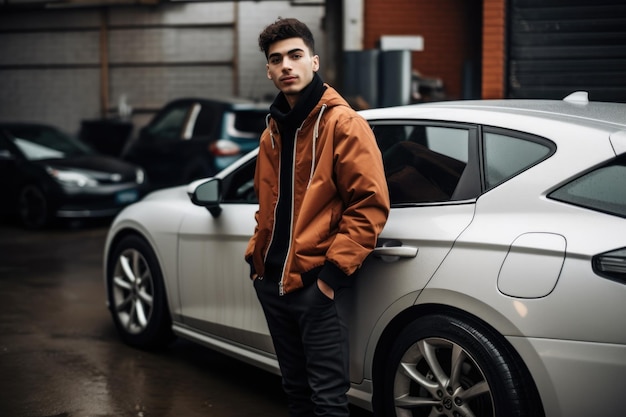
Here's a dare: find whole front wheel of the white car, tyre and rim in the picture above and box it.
[107,236,173,349]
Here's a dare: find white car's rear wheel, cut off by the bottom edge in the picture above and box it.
[381,314,543,417]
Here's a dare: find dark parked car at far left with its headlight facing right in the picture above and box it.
[0,123,147,229]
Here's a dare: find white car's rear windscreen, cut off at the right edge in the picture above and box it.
[548,156,626,217]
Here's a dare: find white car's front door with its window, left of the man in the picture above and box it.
[179,154,274,353]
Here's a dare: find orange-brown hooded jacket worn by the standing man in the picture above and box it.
[245,86,389,294]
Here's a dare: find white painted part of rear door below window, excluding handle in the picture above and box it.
[350,200,474,382]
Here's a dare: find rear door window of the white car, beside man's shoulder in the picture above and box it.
[372,122,470,204]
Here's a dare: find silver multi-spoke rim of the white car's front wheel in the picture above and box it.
[111,249,154,334]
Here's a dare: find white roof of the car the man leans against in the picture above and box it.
[360,94,626,130]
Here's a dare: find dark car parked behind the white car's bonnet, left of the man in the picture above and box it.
[122,98,269,188]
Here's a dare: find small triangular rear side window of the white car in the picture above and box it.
[483,130,553,190]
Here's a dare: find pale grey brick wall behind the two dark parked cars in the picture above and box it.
[0,0,324,133]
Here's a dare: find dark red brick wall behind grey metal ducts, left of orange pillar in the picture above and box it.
[363,0,478,99]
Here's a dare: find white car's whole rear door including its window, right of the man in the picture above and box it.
[350,120,480,382]
